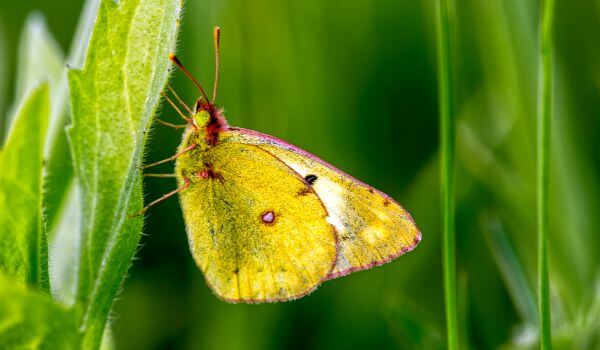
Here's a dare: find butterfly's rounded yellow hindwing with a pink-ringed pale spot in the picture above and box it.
[177,142,337,302]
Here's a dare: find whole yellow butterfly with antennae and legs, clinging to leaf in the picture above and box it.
[141,27,421,303]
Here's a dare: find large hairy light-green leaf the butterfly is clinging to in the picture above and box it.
[68,0,181,348]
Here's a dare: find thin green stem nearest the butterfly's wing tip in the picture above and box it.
[437,0,458,350]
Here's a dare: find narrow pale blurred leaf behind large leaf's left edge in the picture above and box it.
[44,0,100,305]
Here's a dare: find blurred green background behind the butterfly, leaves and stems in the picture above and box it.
[0,0,600,349]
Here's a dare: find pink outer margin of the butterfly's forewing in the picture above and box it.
[228,127,422,281]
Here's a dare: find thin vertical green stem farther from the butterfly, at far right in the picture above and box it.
[537,0,554,349]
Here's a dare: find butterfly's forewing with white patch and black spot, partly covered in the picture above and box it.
[221,128,421,279]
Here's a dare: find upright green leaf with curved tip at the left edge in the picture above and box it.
[0,83,50,290]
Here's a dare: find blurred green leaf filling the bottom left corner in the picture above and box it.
[0,273,77,349]
